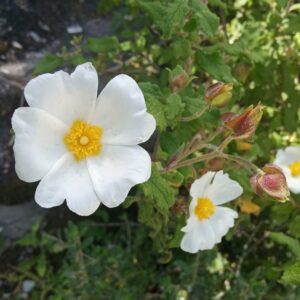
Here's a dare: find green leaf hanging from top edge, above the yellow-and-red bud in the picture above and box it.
[191,0,219,37]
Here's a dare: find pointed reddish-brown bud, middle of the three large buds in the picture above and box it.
[222,104,263,139]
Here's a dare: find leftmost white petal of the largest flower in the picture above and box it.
[12,107,68,182]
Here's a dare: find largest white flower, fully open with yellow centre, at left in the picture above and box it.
[12,63,156,216]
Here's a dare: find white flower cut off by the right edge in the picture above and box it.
[274,146,300,194]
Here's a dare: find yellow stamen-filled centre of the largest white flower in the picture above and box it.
[64,120,103,161]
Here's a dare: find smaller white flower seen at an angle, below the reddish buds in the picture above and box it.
[180,171,243,253]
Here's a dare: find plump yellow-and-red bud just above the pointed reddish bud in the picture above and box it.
[205,82,232,108]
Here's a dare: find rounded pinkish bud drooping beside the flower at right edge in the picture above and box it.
[250,164,290,202]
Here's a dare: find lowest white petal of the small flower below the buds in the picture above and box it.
[180,220,216,253]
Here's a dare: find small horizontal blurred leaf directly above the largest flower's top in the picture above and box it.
[84,36,119,53]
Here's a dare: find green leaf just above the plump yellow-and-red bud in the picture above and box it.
[196,51,235,82]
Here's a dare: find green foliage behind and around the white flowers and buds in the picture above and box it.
[0,0,300,300]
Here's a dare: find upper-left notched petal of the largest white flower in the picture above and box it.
[24,63,98,125]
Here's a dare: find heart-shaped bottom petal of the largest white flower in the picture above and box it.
[35,153,100,216]
